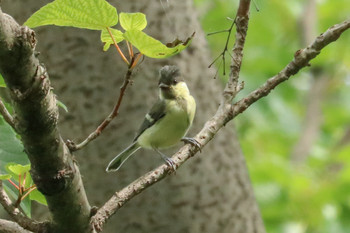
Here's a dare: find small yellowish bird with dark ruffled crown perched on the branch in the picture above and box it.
[106,65,200,172]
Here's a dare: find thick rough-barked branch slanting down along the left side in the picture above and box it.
[0,9,90,232]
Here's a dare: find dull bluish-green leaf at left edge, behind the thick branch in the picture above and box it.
[0,115,29,173]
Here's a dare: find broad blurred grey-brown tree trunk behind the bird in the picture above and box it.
[2,0,265,233]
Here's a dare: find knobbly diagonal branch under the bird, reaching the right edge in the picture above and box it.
[91,16,350,232]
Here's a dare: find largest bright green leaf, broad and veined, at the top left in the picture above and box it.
[24,0,118,30]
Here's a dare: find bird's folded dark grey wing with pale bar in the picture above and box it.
[134,100,166,142]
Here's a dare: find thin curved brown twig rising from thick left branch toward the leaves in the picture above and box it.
[66,67,134,151]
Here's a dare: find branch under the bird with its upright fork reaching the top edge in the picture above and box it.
[91,0,250,231]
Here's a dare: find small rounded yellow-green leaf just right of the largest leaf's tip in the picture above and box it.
[119,12,147,31]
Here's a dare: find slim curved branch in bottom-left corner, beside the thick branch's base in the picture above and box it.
[0,180,48,232]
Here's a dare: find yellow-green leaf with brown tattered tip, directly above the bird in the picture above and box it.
[124,30,194,58]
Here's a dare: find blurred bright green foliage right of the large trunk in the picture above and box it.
[195,0,350,233]
